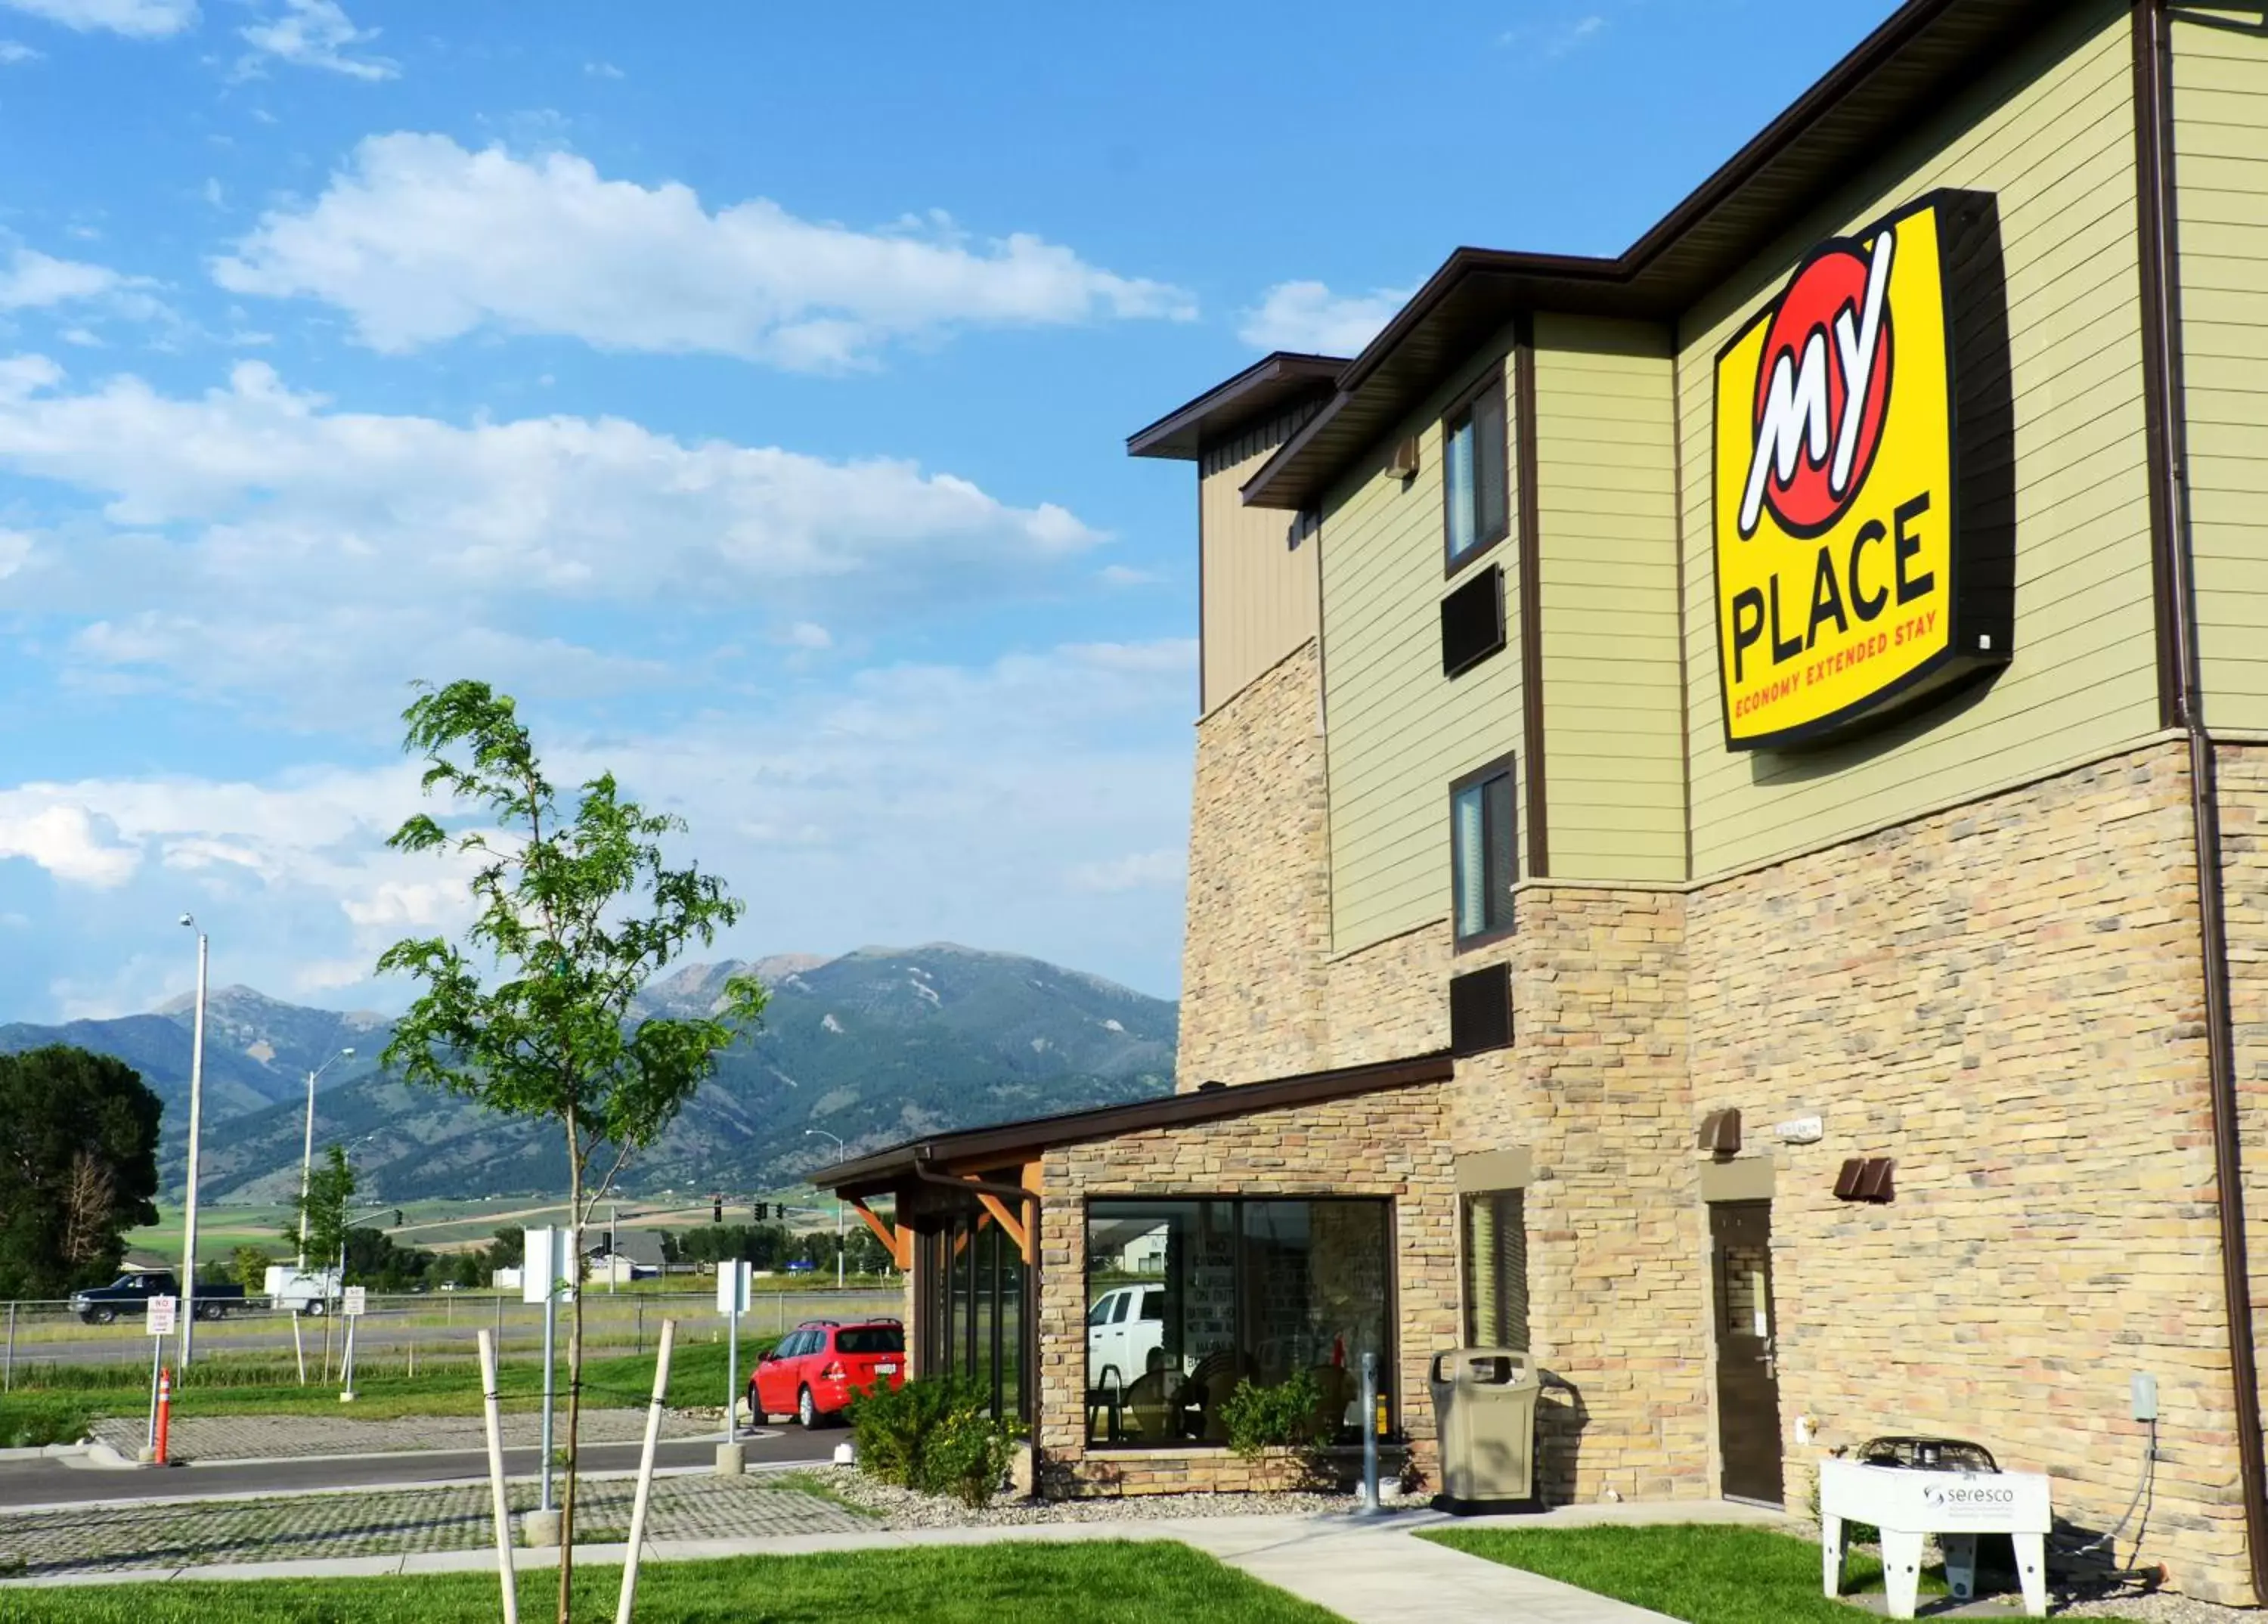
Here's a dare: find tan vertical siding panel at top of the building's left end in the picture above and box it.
[1198,413,1318,710]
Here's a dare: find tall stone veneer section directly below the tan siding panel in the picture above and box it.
[1175,637,1331,1091]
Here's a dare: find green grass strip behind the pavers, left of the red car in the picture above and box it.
[0,1336,778,1447]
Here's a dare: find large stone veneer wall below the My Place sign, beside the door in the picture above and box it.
[1687,744,2259,1599]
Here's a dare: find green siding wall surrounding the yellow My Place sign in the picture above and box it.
[1678,0,2157,878]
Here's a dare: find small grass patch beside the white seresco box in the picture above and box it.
[1420,1524,2141,1624]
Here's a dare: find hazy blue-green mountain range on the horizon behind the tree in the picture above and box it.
[0,944,1177,1202]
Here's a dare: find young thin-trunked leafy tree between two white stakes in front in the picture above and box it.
[379,680,764,1624]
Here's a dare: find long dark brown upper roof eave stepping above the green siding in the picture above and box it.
[1207,0,2068,508]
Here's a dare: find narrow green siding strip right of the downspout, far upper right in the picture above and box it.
[2173,5,2268,728]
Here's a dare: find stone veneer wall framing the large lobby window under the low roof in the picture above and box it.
[1036,1084,1458,1495]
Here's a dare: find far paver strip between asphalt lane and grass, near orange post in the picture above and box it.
[95,1409,723,1461]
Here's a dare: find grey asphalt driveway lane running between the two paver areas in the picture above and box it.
[0,1427,848,1511]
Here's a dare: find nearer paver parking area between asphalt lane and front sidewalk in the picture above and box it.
[0,1474,873,1570]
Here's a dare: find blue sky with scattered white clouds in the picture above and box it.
[0,0,1889,1018]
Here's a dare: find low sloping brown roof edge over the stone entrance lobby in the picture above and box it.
[812,1050,1454,1195]
